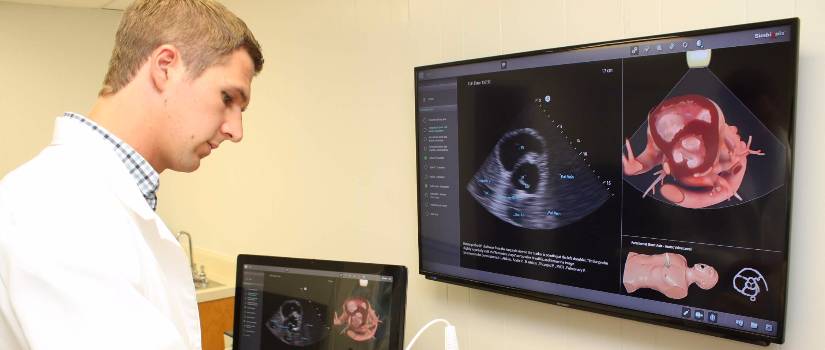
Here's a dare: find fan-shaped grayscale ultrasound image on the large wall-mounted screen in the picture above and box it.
[467,128,609,229]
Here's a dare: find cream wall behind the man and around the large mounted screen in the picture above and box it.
[0,0,825,350]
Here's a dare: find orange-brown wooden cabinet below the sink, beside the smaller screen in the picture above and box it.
[198,297,235,350]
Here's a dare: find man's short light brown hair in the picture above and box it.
[100,0,264,96]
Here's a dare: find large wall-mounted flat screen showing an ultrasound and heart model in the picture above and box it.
[414,19,799,343]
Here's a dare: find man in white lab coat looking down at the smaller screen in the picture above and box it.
[0,0,263,349]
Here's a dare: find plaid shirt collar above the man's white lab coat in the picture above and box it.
[63,112,160,210]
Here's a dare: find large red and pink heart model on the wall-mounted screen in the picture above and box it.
[622,95,764,208]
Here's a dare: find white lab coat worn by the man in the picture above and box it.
[0,117,201,350]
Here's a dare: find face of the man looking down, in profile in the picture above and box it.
[156,49,254,172]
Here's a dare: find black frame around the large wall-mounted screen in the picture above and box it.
[413,18,800,346]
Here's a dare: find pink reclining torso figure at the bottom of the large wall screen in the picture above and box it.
[622,252,719,299]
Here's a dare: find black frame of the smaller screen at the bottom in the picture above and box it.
[232,254,407,350]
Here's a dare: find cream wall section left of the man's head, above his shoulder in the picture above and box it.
[0,2,120,176]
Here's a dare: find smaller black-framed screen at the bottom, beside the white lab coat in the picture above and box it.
[232,255,407,350]
